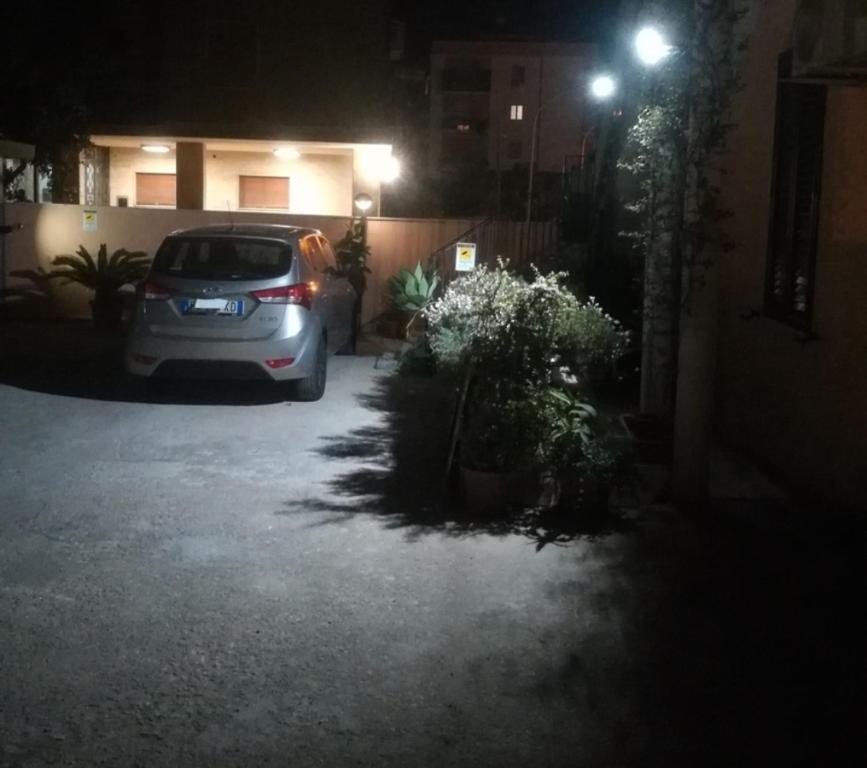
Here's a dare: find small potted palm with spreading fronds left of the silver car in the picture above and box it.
[48,243,149,330]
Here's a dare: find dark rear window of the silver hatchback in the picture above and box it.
[153,237,292,280]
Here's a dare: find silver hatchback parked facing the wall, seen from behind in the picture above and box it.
[125,224,356,400]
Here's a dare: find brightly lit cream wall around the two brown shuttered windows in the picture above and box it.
[109,147,354,216]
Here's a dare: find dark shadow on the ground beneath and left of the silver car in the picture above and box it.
[0,321,290,405]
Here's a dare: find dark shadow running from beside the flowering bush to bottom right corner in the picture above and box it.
[280,368,867,768]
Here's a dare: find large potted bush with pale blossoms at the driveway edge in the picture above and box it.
[425,264,626,509]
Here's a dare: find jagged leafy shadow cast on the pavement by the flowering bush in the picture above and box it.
[281,375,631,549]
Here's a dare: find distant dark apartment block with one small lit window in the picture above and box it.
[430,41,594,173]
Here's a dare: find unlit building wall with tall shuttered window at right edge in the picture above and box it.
[716,0,867,509]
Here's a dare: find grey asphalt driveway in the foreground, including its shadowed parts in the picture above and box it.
[0,328,864,768]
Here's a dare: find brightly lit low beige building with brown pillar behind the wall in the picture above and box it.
[79,135,397,216]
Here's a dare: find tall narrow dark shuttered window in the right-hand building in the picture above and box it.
[765,53,826,329]
